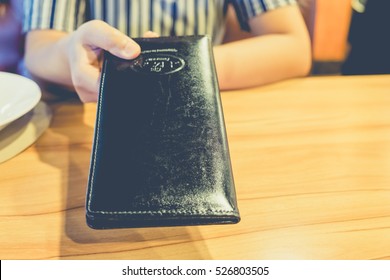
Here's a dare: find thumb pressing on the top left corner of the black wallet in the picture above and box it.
[77,20,141,59]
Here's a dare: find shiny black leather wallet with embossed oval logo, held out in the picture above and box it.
[86,36,240,229]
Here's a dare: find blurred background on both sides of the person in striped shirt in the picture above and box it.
[0,0,390,75]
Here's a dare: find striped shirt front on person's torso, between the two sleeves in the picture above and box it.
[87,0,226,43]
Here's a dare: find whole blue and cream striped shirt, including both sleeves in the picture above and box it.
[23,0,296,43]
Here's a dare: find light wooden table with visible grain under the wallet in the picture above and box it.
[0,76,390,259]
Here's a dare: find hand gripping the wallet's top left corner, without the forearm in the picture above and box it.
[67,20,141,102]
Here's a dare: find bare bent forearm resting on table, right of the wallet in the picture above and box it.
[214,5,311,90]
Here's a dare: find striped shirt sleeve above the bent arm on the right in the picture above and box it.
[230,0,297,31]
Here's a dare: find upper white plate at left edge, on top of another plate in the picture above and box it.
[0,72,42,130]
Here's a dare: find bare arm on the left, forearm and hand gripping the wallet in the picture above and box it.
[25,20,140,102]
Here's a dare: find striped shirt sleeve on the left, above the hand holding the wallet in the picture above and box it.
[23,0,87,32]
